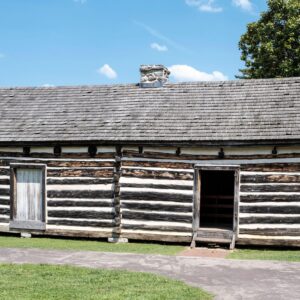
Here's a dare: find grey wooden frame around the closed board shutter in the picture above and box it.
[9,163,47,230]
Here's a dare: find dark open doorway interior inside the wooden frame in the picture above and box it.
[199,170,235,230]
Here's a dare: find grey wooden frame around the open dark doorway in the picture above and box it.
[193,164,240,236]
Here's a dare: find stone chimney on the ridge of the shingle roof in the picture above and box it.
[140,65,170,88]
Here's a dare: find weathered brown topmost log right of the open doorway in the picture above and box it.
[241,163,300,172]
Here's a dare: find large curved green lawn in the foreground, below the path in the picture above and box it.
[0,264,212,300]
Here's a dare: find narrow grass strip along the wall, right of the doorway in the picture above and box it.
[226,249,300,262]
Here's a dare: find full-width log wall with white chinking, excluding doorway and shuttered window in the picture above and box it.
[0,146,300,246]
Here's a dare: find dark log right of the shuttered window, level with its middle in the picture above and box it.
[47,190,113,199]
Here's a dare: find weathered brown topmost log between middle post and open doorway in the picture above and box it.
[122,158,194,169]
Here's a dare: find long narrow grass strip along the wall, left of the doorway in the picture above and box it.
[0,236,186,255]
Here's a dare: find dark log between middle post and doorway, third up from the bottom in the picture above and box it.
[122,210,192,223]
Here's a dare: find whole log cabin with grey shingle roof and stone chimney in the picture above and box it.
[0,65,300,248]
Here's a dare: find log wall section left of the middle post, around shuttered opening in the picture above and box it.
[0,153,115,237]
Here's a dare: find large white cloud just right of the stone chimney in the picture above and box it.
[168,65,228,82]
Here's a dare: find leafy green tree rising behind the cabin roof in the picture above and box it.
[236,0,300,79]
